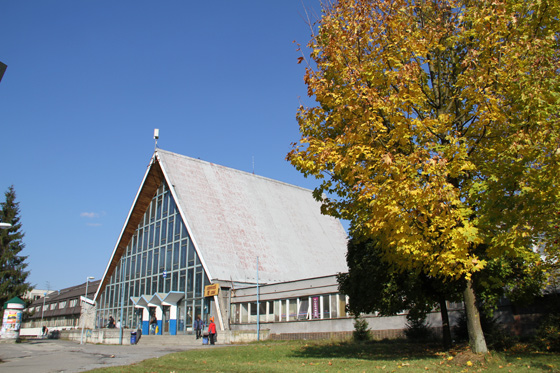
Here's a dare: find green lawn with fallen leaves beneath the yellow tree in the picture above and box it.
[87,341,560,373]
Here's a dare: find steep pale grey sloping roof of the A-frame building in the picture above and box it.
[96,149,347,298]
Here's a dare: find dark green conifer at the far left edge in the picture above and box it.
[0,185,31,309]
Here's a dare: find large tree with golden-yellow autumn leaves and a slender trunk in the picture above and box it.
[288,0,560,353]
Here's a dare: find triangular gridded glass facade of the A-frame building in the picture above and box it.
[97,182,210,334]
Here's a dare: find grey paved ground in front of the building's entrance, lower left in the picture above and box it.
[0,339,206,373]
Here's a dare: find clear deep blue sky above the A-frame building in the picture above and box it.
[0,0,332,290]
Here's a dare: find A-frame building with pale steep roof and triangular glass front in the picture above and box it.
[95,149,347,335]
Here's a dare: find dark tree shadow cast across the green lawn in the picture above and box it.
[292,340,441,360]
